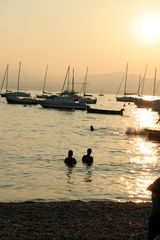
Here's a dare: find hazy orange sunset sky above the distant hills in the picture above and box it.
[0,0,160,93]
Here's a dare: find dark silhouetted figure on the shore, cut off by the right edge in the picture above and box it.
[147,178,160,240]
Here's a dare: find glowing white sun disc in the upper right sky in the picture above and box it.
[134,15,160,42]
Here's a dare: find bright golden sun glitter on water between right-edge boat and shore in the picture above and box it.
[125,131,158,202]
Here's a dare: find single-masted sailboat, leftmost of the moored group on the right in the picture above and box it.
[116,63,135,102]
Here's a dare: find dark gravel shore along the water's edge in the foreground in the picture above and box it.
[0,201,151,240]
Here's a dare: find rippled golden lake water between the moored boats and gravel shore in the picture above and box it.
[0,95,160,201]
